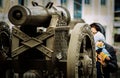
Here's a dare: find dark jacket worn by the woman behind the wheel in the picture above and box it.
[103,43,118,78]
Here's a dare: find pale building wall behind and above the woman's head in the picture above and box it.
[82,0,114,45]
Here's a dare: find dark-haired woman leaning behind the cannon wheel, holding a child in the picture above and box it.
[90,23,118,78]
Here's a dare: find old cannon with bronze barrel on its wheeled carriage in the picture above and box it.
[2,2,96,78]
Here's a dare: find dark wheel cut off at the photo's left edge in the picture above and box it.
[0,21,13,78]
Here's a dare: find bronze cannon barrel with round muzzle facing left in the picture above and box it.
[8,5,70,26]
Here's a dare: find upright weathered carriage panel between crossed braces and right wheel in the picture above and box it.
[53,26,69,60]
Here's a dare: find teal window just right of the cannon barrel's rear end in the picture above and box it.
[74,0,82,19]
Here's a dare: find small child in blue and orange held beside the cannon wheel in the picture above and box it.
[95,40,111,78]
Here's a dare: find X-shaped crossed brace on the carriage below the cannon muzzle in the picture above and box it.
[12,27,53,57]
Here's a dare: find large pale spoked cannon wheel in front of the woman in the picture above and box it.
[67,23,96,78]
